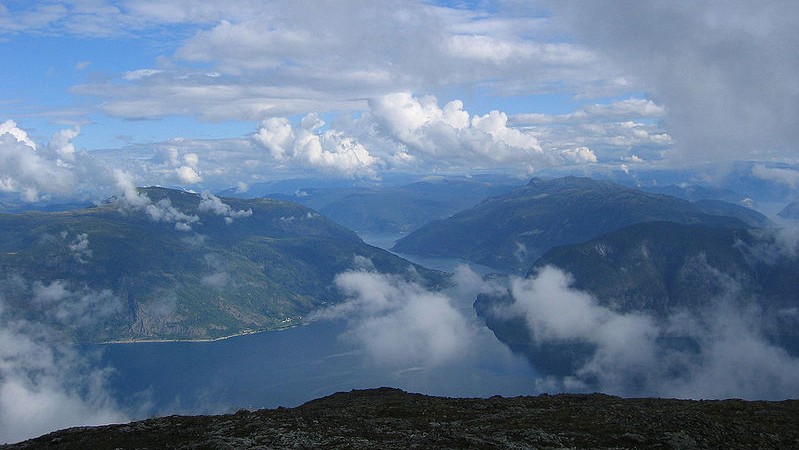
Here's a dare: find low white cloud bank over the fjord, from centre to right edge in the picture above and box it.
[313,266,799,399]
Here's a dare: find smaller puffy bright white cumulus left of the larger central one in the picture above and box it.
[253,114,380,177]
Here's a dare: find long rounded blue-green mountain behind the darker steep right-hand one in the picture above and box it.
[393,177,767,272]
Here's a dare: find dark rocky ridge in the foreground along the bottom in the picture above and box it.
[6,388,799,449]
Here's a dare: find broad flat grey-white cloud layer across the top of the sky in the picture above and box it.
[56,0,625,120]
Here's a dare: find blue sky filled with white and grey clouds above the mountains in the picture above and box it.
[0,0,799,201]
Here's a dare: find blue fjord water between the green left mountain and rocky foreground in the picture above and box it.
[101,235,536,415]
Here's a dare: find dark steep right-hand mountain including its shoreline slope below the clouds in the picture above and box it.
[474,222,799,374]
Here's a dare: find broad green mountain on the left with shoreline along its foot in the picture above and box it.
[0,188,442,341]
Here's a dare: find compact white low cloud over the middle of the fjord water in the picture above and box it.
[312,268,474,367]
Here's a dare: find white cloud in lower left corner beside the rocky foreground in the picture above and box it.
[0,296,129,442]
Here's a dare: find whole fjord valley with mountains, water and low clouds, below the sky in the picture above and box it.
[0,173,799,442]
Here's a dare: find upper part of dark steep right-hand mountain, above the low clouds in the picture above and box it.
[531,222,799,316]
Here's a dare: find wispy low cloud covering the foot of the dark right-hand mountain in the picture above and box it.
[495,266,799,399]
